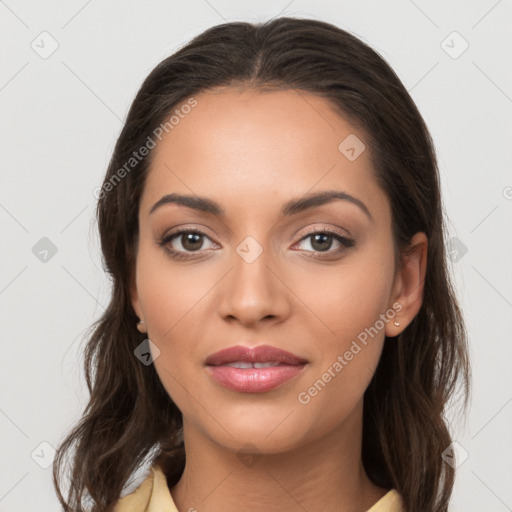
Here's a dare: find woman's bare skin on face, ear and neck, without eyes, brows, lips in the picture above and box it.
[132,88,427,512]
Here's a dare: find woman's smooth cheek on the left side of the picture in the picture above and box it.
[137,246,225,412]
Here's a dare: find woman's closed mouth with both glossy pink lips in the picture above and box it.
[206,345,308,393]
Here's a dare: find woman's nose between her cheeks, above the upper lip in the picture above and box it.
[218,240,292,326]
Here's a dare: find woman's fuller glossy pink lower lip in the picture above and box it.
[206,364,306,393]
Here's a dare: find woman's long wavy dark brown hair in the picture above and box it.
[53,17,470,512]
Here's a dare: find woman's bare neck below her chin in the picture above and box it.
[170,404,386,512]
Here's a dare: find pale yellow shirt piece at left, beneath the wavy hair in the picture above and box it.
[113,466,177,512]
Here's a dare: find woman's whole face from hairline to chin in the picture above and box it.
[132,88,403,453]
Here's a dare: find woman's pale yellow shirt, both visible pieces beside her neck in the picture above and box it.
[114,466,403,512]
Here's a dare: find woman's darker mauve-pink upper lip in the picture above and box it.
[206,345,307,366]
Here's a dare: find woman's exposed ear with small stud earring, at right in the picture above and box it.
[386,232,428,337]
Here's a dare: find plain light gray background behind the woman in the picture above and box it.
[0,0,512,512]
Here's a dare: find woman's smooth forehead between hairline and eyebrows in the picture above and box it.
[141,87,387,223]
